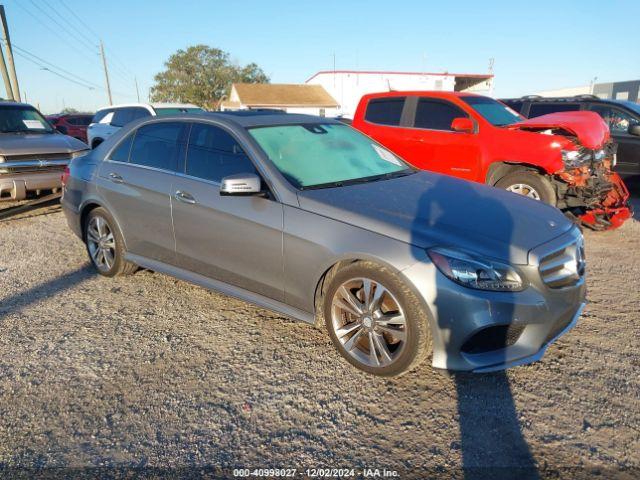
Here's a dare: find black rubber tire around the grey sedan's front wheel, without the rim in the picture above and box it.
[320,261,431,377]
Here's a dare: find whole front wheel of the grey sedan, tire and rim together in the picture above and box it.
[321,262,431,377]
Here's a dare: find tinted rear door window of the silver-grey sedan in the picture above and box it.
[129,122,188,171]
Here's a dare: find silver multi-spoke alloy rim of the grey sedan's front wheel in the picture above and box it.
[331,278,407,367]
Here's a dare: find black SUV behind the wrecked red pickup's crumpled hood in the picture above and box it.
[502,95,640,188]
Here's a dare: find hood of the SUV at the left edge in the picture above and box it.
[0,133,89,156]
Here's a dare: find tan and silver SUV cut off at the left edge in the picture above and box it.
[0,102,87,201]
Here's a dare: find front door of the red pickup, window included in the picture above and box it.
[407,97,480,180]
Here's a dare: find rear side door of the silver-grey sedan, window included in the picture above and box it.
[97,121,189,264]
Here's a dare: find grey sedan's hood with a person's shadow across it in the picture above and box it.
[298,172,573,264]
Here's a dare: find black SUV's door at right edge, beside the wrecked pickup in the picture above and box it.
[590,104,640,177]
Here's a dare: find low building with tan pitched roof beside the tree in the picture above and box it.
[220,83,339,117]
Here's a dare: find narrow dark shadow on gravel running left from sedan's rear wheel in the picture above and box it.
[0,263,97,321]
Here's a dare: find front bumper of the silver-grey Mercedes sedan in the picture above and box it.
[402,229,586,372]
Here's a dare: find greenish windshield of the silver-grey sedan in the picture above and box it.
[249,123,414,189]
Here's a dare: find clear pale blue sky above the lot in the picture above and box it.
[0,0,640,114]
